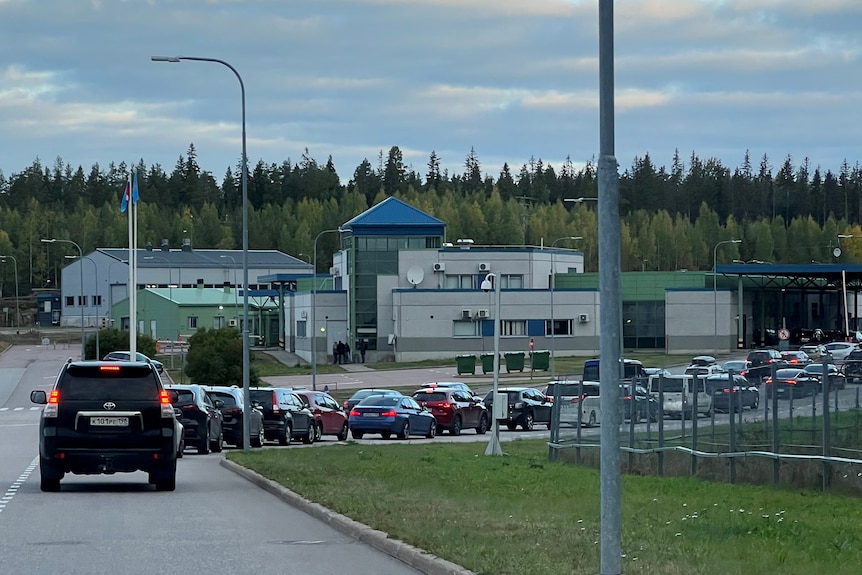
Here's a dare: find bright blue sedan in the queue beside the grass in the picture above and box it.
[348,395,437,439]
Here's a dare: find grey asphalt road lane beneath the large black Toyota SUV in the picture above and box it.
[0,346,426,575]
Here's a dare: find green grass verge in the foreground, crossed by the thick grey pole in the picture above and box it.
[228,440,862,575]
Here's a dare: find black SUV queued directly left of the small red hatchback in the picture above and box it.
[249,387,317,445]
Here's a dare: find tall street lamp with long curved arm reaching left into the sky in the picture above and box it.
[151,56,251,451]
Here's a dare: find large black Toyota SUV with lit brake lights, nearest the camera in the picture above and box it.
[30,360,182,491]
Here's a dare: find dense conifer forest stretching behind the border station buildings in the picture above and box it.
[0,144,862,297]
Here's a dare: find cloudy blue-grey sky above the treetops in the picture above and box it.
[0,0,862,181]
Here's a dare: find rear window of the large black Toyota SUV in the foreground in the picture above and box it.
[58,366,161,401]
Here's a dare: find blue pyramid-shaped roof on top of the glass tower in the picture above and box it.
[341,196,446,236]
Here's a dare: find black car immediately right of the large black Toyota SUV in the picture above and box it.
[165,384,224,455]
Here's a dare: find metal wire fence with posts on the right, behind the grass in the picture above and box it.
[549,362,862,495]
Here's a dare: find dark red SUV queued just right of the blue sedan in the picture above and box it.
[413,387,491,435]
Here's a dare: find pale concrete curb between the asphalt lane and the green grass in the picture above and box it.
[219,459,476,575]
